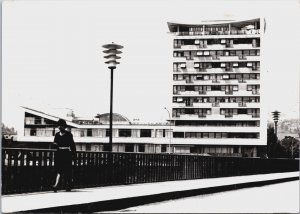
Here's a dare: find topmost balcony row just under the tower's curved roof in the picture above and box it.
[175,29,260,36]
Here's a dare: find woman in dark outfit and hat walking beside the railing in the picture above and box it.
[52,119,76,192]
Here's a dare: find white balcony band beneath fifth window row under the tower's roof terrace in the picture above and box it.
[173,89,260,96]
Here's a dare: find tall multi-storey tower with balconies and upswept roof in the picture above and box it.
[168,18,266,157]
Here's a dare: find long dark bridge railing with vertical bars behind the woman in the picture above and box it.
[2,148,299,194]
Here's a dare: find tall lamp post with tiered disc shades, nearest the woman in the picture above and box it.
[102,43,123,151]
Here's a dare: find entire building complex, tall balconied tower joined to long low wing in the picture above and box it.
[18,19,267,157]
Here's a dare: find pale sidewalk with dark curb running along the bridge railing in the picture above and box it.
[2,172,299,213]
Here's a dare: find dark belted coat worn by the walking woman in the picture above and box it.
[54,131,76,173]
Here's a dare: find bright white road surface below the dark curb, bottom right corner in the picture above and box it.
[101,180,299,213]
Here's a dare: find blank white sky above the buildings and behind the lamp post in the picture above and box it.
[2,0,300,126]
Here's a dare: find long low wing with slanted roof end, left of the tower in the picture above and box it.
[18,107,173,153]
